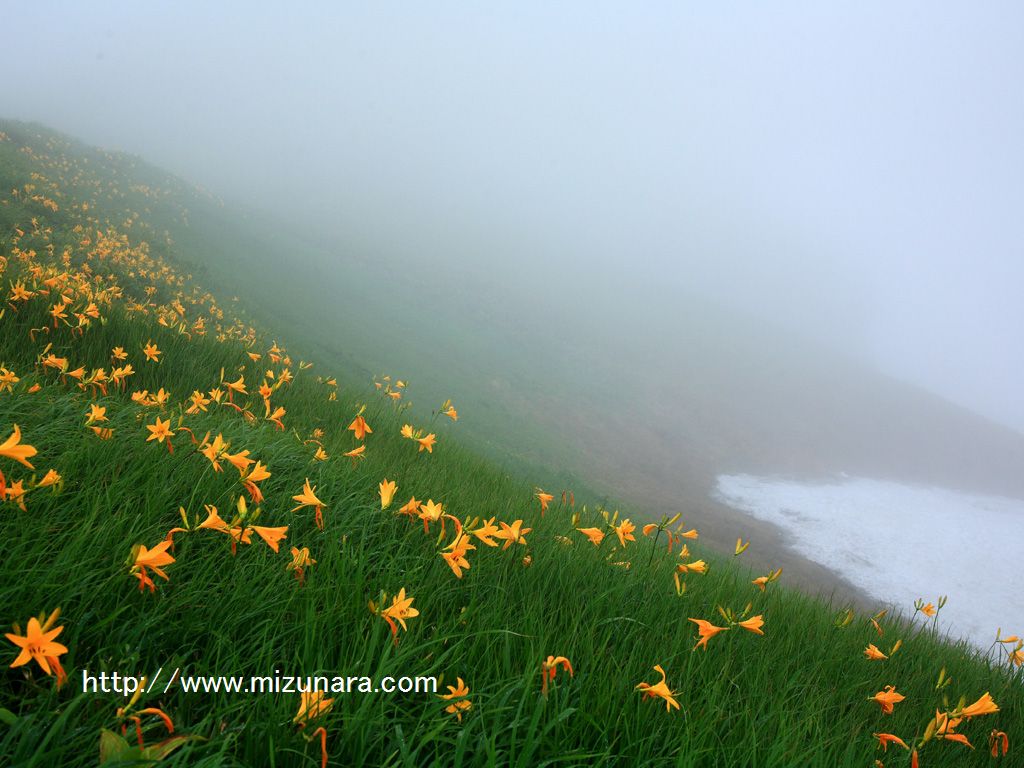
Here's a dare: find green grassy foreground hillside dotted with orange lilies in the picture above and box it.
[0,123,1024,766]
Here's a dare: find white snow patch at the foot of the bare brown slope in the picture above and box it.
[714,475,1024,649]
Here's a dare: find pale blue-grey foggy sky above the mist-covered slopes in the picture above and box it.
[0,0,1024,430]
